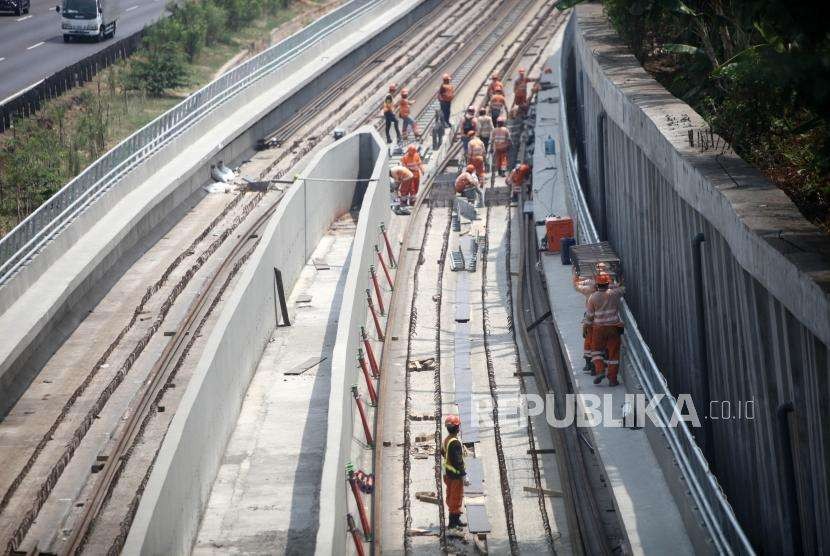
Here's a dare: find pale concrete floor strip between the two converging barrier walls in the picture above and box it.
[193,227,355,554]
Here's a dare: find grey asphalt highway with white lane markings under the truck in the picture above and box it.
[0,0,165,104]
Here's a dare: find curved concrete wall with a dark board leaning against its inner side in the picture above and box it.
[124,129,380,554]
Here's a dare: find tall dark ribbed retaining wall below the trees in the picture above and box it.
[563,5,830,553]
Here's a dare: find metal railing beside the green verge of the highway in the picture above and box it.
[0,0,382,286]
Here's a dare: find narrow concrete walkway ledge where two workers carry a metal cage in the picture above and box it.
[533,34,695,554]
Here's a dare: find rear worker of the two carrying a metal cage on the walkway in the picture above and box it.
[585,272,625,386]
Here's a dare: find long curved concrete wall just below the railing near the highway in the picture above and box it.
[0,0,438,415]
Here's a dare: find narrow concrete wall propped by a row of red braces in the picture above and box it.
[316,129,391,554]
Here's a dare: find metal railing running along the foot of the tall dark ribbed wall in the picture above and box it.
[559,50,755,554]
